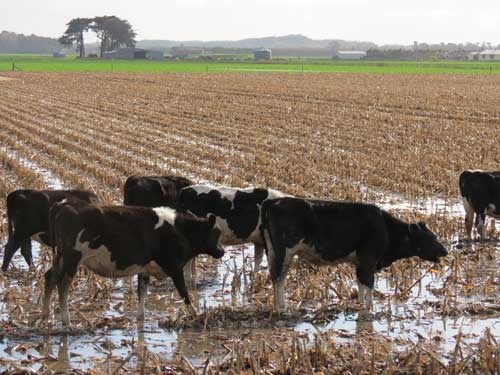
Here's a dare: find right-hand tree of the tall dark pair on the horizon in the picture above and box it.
[90,16,136,57]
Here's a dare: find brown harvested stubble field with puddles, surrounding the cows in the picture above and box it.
[0,73,500,374]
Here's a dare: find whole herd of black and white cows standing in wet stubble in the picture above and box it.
[2,171,500,325]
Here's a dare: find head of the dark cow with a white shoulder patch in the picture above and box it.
[176,213,224,259]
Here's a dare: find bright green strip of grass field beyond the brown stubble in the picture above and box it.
[0,54,500,74]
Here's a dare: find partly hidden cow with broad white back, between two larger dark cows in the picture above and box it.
[178,185,289,272]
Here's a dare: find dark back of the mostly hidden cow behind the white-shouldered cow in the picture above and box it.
[123,176,193,209]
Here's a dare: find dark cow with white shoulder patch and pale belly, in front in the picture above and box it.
[42,204,224,325]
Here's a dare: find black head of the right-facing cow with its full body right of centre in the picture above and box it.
[408,222,448,262]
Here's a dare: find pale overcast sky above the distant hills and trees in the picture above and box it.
[0,0,500,44]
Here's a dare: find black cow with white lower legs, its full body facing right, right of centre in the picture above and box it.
[262,198,447,311]
